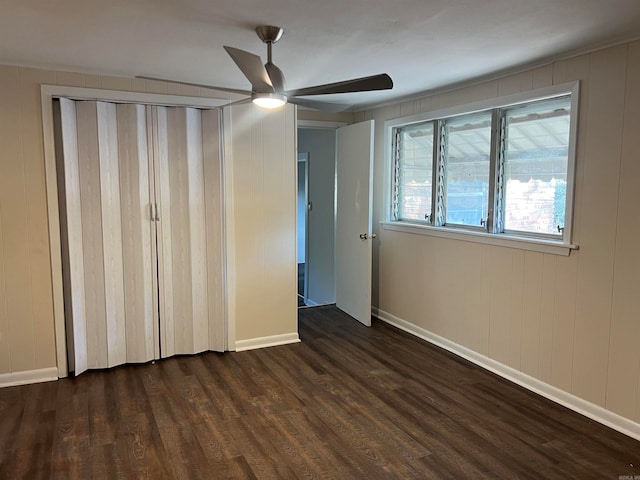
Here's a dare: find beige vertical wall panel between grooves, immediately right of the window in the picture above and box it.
[572,46,627,405]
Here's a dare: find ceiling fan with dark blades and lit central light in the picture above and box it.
[137,25,393,112]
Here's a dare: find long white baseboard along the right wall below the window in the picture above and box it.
[371,307,640,440]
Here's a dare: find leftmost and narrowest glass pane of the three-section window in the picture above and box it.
[397,122,433,221]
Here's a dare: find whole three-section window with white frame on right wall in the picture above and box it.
[387,84,577,249]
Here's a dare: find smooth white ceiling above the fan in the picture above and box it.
[0,0,640,106]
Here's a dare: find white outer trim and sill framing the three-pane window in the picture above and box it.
[381,81,580,256]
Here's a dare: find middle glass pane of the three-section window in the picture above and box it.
[444,113,491,227]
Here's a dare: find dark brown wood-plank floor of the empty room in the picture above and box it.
[0,307,640,480]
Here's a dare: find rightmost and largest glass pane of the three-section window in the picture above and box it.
[504,98,571,236]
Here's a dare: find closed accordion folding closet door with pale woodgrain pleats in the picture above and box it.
[54,98,226,375]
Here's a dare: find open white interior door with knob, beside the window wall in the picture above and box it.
[336,120,374,326]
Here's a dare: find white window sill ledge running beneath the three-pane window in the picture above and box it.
[381,222,578,257]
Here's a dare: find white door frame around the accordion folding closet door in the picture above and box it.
[40,85,230,378]
